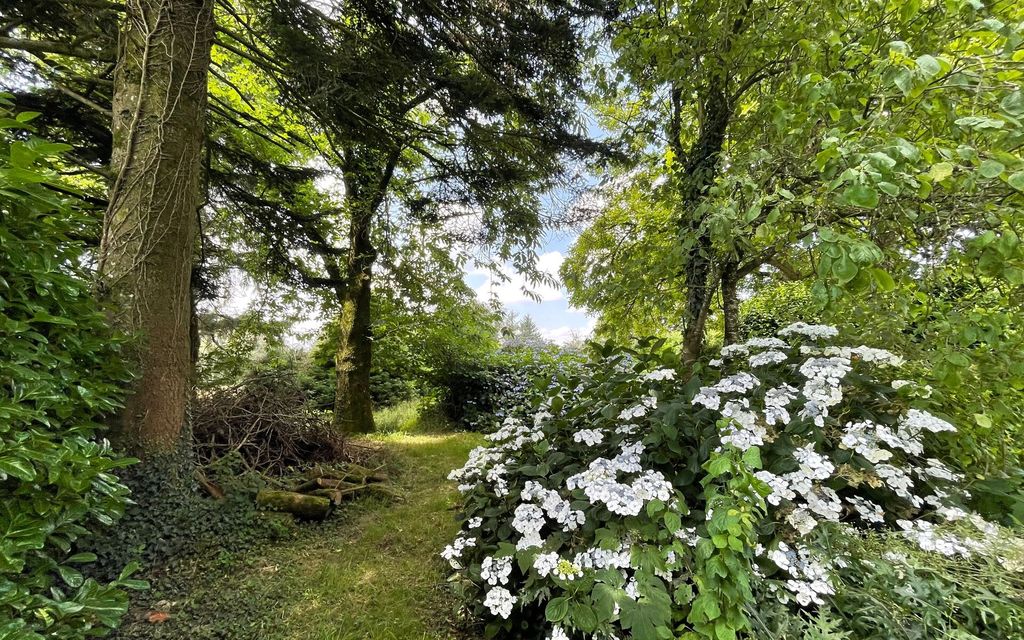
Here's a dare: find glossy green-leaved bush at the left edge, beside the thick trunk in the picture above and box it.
[0,103,142,640]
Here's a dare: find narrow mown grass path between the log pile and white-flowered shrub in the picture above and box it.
[282,433,479,640]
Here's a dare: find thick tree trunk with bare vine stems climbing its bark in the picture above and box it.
[98,0,213,456]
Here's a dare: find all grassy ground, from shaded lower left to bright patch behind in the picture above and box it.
[113,404,482,640]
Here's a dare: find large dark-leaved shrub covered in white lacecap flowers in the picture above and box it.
[442,323,1022,640]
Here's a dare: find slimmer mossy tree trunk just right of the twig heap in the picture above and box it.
[334,199,377,433]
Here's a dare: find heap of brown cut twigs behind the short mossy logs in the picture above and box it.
[193,371,347,476]
